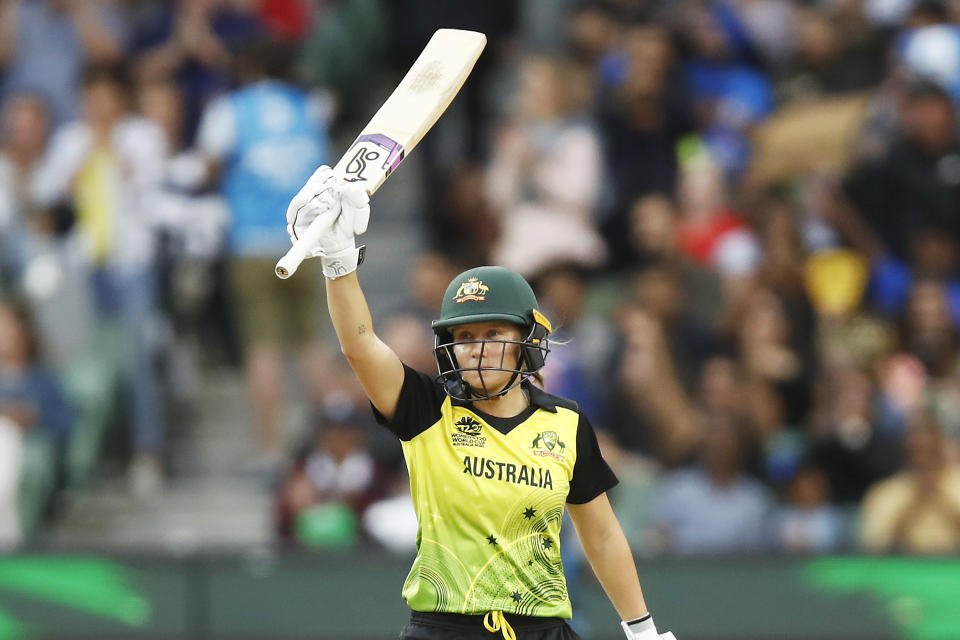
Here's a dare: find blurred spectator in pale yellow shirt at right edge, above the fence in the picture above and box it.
[861,413,960,554]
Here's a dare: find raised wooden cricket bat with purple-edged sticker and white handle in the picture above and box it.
[276,29,487,279]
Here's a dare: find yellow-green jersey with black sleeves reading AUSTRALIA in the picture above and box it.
[378,367,617,618]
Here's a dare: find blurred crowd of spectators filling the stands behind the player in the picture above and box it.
[0,0,960,554]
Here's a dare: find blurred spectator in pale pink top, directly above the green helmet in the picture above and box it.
[487,55,606,275]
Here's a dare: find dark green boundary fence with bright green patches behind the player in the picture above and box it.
[0,550,960,640]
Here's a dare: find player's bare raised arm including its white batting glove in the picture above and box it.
[287,166,404,418]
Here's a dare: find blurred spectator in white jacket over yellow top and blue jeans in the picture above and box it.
[31,66,167,495]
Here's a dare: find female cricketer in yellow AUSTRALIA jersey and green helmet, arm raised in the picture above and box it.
[287,166,673,640]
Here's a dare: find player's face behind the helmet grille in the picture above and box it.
[452,322,523,394]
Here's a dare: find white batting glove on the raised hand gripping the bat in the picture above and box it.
[287,165,370,278]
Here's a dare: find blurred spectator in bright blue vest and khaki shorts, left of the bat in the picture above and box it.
[198,39,330,474]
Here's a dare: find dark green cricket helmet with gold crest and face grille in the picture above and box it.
[432,266,551,401]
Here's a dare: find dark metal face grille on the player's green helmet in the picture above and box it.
[433,325,550,402]
